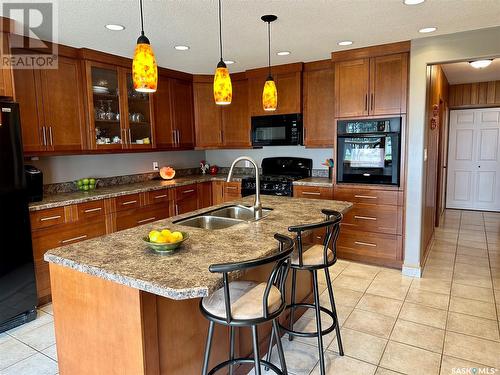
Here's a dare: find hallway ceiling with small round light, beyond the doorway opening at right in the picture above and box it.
[441,58,500,85]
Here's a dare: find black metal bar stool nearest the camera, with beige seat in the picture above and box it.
[200,234,294,375]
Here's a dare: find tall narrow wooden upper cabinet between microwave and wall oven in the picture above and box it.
[302,60,335,147]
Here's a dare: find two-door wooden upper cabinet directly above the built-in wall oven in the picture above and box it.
[332,42,409,117]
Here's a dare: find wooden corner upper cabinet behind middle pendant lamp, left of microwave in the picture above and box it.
[193,74,251,149]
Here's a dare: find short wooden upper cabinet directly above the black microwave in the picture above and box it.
[246,63,303,116]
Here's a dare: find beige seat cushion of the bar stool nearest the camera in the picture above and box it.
[202,281,281,320]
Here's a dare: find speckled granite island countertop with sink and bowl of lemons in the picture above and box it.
[44,196,352,300]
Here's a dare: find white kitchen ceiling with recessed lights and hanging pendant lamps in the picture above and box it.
[4,0,500,73]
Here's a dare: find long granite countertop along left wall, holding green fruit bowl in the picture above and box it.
[29,174,245,211]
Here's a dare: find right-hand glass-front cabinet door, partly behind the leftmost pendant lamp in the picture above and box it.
[125,70,154,148]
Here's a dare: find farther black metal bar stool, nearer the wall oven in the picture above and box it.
[266,210,344,375]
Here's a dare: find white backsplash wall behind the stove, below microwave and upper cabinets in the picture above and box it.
[205,146,333,170]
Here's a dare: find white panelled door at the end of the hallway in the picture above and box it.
[446,108,500,211]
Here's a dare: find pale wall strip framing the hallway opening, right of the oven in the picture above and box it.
[403,27,500,275]
